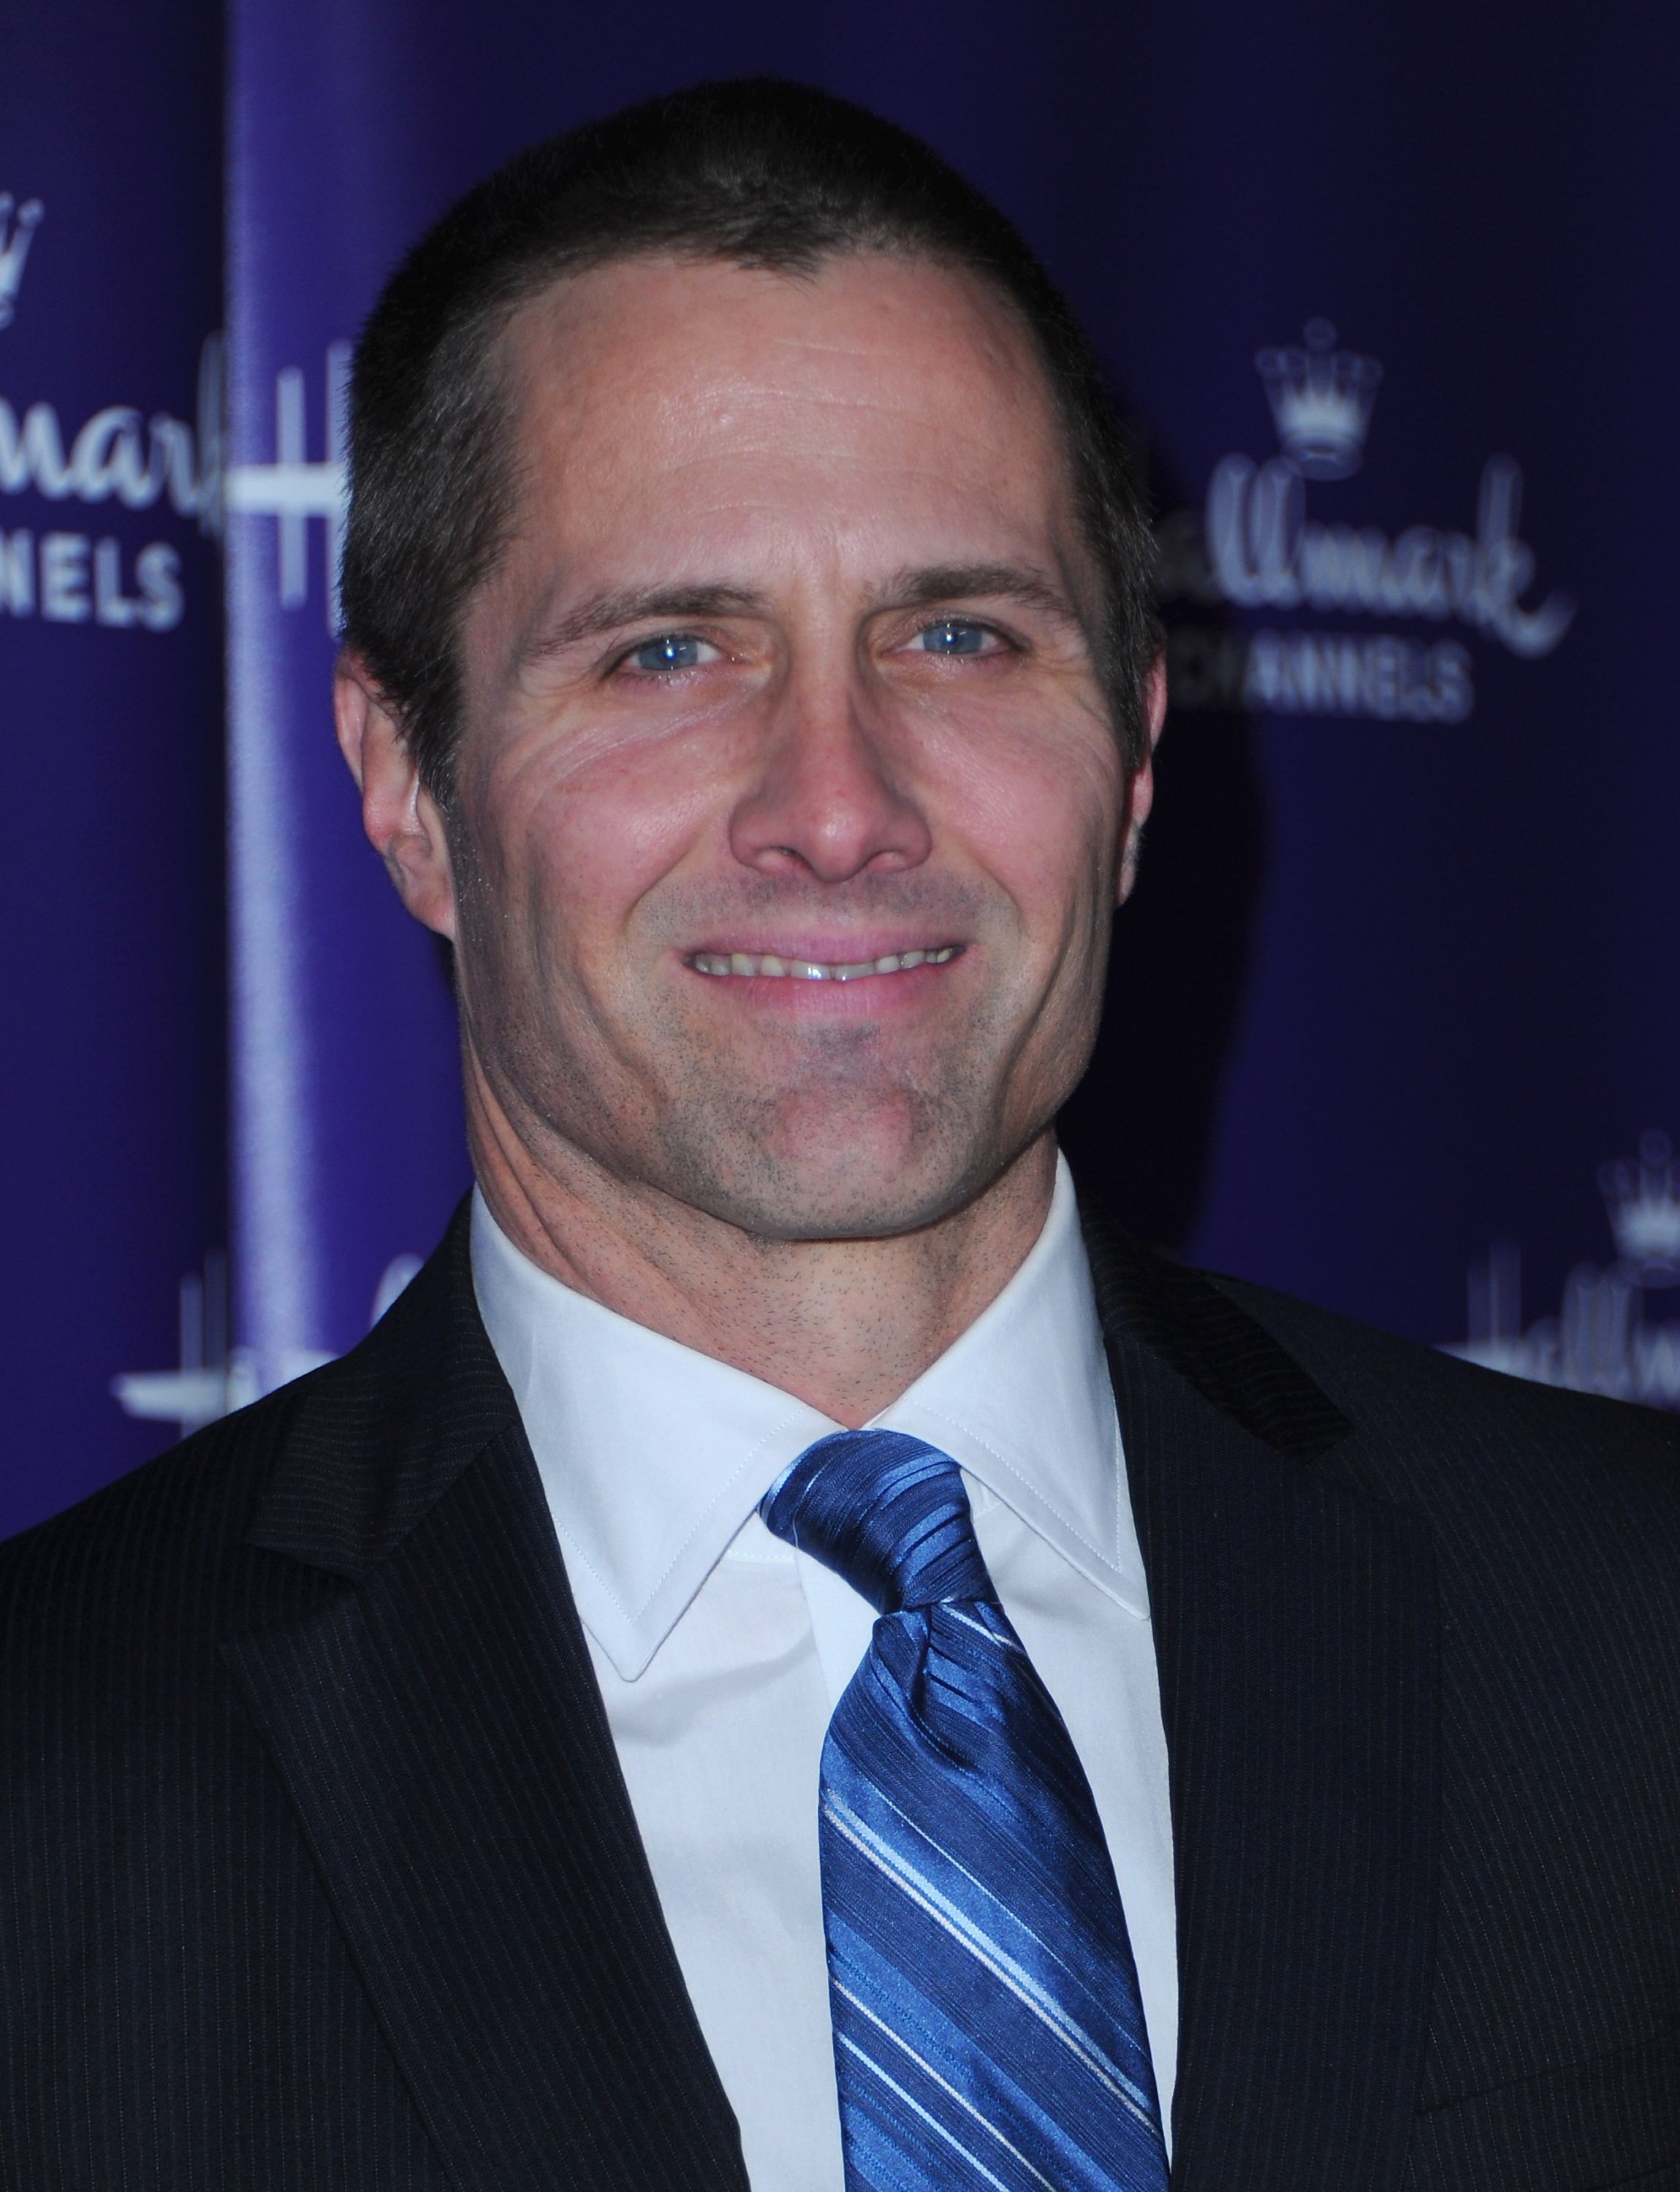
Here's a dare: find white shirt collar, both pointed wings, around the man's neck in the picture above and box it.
[471,1160,1149,1681]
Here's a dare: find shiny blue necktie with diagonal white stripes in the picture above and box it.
[761,1431,1167,2192]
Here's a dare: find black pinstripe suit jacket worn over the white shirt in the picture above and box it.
[0,1219,1680,2192]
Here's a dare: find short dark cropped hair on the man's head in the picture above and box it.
[342,77,1160,798]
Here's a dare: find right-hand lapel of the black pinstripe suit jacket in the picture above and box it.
[1088,1223,1437,2192]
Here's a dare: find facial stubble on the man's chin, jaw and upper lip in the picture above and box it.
[452,831,1101,1241]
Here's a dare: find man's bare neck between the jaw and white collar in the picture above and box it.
[467,1068,1055,1429]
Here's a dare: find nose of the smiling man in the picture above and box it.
[730,675,932,883]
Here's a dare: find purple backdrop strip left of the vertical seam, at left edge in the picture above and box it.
[0,4,226,1530]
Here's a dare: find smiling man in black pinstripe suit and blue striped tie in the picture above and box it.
[0,72,1680,2192]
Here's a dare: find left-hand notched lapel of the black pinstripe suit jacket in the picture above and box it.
[224,1212,745,2192]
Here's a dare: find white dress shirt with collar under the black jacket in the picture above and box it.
[471,1164,1178,2192]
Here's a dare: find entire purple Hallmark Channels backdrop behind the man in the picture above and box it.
[0,0,1680,1528]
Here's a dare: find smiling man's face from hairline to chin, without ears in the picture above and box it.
[445,256,1147,1238]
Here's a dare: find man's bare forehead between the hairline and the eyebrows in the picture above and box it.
[493,252,1066,574]
